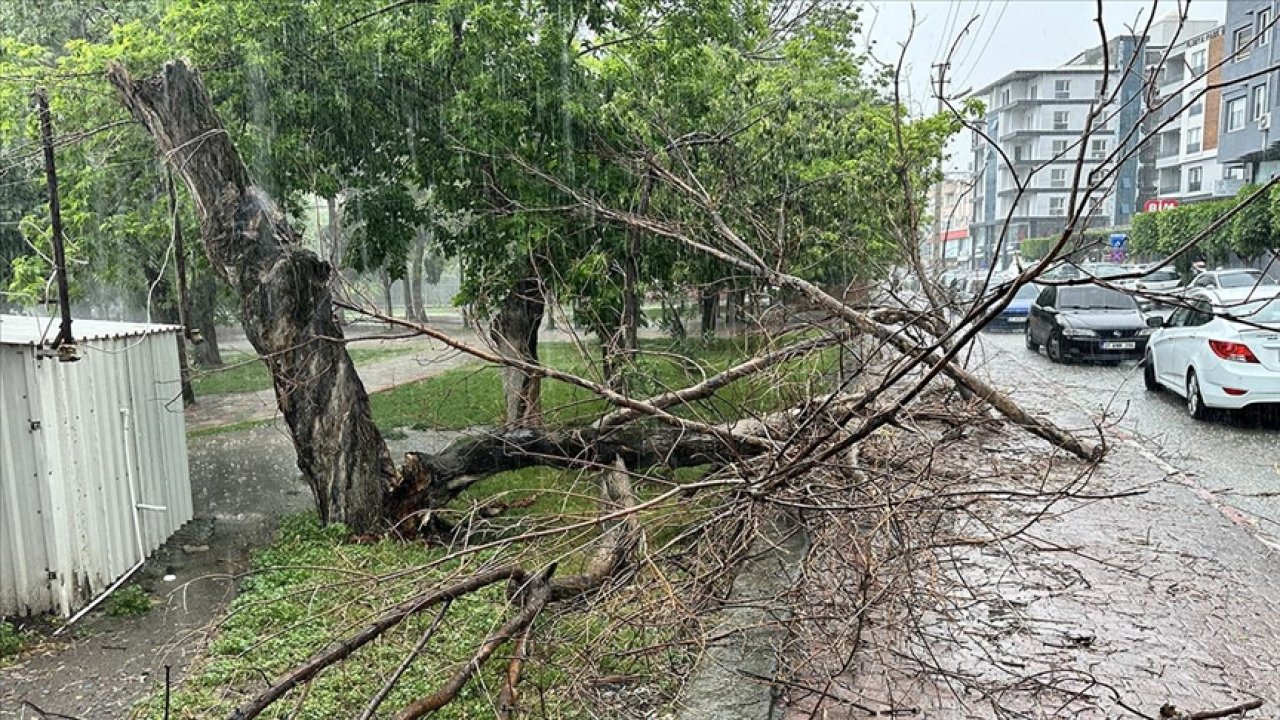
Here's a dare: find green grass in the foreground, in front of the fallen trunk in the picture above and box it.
[133,510,691,720]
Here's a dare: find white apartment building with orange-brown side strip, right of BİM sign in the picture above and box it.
[1148,26,1228,204]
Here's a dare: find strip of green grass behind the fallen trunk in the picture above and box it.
[370,338,836,430]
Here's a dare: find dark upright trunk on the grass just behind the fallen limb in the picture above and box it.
[489,275,547,425]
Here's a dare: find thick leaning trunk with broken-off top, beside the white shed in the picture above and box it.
[108,61,396,532]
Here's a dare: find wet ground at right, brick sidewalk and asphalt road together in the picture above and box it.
[785,334,1280,720]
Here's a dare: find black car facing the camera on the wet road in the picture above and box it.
[1027,284,1153,363]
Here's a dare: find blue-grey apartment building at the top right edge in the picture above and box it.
[1219,0,1280,184]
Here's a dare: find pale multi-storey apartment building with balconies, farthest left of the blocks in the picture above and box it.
[969,18,1217,269]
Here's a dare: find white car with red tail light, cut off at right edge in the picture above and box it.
[1143,287,1280,420]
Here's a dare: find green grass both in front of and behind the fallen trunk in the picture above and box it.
[152,338,819,720]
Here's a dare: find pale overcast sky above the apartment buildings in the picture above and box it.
[863,0,1226,169]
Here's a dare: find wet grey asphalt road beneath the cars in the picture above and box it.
[973,333,1280,537]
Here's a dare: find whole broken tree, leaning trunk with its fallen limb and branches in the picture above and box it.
[109,56,1097,719]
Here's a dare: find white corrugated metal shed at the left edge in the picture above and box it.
[0,315,192,616]
